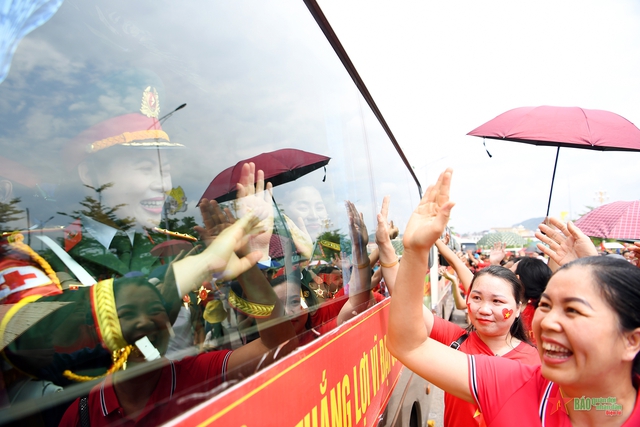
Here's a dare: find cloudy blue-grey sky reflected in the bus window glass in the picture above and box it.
[0,0,418,239]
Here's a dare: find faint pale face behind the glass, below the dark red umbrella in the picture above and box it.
[284,186,328,240]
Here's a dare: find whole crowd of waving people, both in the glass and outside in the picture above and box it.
[0,74,640,426]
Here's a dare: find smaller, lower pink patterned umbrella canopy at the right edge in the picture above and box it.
[575,200,640,240]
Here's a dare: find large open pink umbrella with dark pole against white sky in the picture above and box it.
[467,105,640,216]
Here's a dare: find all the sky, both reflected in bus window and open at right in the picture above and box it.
[0,0,640,237]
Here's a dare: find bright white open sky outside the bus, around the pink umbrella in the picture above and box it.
[319,0,640,233]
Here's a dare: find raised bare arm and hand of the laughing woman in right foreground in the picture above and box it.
[387,169,473,402]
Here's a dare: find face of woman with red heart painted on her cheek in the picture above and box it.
[467,274,520,337]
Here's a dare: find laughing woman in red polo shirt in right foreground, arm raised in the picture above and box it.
[387,169,640,427]
